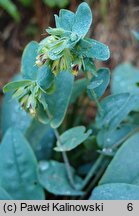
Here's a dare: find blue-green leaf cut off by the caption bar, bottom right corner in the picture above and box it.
[89,183,139,200]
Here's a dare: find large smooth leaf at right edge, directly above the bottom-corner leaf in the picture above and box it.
[100,133,139,185]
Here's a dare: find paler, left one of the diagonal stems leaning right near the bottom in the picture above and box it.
[81,155,105,189]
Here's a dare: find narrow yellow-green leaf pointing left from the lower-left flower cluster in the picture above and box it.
[3,80,31,93]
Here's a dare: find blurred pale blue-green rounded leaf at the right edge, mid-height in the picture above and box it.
[111,63,139,110]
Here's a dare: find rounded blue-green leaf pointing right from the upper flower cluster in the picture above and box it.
[86,39,110,61]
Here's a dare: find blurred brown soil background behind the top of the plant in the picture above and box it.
[0,0,139,98]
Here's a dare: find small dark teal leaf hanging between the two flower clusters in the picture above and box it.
[37,65,54,91]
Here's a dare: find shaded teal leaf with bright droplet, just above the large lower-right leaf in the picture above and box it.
[97,124,135,148]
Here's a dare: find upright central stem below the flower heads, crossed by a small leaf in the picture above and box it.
[47,110,75,189]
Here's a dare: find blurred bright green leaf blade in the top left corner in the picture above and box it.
[0,0,21,22]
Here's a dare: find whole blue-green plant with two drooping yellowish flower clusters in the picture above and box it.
[0,3,139,199]
